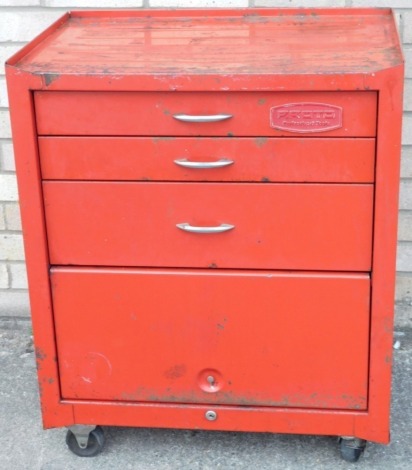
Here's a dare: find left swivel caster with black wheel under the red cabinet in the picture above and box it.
[66,424,105,457]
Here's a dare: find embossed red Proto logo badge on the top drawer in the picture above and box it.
[270,103,343,133]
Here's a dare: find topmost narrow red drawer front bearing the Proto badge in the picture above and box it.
[34,91,377,137]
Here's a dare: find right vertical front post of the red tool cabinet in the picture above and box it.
[356,66,403,443]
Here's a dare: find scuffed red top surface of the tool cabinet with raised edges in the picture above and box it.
[9,9,403,75]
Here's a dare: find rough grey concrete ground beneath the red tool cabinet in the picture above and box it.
[0,318,412,470]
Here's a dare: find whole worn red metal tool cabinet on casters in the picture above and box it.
[7,9,403,460]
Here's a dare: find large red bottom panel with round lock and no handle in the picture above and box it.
[51,268,370,409]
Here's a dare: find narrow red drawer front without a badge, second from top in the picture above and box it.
[39,137,375,183]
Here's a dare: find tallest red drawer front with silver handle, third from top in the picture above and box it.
[43,181,373,271]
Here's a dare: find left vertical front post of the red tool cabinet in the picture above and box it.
[7,67,73,427]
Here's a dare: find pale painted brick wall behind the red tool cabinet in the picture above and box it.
[0,0,412,323]
